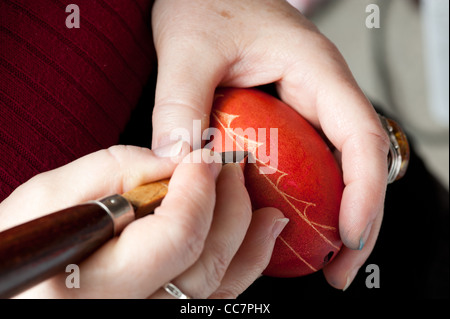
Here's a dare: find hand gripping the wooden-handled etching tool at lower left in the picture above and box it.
[0,143,286,298]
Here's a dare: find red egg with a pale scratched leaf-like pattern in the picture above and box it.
[208,88,344,277]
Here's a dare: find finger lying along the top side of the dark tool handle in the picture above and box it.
[0,142,187,228]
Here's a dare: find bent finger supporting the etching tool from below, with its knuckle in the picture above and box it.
[14,151,221,298]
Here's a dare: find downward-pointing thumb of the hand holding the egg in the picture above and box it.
[152,2,230,149]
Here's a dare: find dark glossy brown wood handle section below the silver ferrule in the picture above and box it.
[0,203,114,298]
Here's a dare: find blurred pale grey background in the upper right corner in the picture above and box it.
[288,0,449,189]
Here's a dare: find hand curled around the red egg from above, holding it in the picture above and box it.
[152,0,389,289]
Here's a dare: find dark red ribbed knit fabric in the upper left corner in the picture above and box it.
[0,0,155,202]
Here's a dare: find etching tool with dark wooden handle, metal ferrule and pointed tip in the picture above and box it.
[0,152,247,298]
